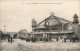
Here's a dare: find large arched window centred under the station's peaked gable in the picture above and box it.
[46,18,62,30]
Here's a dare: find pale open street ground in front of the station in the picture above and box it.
[1,39,80,51]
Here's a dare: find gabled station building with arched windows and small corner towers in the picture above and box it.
[30,13,80,41]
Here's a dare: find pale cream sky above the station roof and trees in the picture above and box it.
[0,0,80,32]
